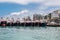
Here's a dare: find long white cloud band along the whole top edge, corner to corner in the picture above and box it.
[0,0,60,6]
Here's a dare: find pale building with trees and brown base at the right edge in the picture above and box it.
[45,10,60,23]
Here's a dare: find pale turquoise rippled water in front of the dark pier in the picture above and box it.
[0,27,60,40]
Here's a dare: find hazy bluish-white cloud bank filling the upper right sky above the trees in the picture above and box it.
[36,0,60,15]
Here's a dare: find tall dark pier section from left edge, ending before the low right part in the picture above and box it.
[0,21,46,26]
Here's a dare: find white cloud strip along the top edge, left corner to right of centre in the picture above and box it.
[0,0,43,4]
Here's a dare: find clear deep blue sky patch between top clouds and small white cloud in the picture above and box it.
[0,2,39,16]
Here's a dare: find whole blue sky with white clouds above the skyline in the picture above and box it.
[0,0,60,18]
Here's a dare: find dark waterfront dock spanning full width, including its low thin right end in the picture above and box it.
[0,21,60,27]
